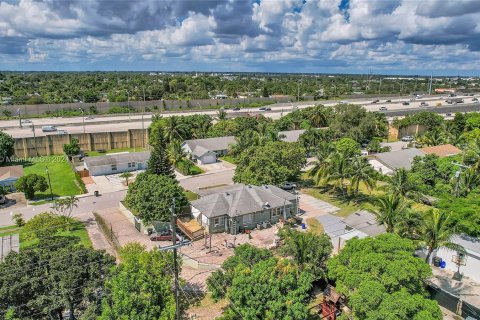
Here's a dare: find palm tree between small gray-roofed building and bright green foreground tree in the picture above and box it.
[372,194,410,233]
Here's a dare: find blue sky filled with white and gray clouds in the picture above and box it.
[0,0,480,76]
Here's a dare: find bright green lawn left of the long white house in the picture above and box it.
[23,156,81,200]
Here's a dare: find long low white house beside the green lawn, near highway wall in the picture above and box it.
[83,151,150,176]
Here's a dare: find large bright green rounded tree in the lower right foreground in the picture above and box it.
[327,234,442,320]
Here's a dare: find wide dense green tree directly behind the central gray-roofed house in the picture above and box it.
[233,141,307,185]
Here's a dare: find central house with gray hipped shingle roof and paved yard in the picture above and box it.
[191,184,298,234]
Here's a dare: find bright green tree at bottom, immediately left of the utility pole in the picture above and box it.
[98,243,175,320]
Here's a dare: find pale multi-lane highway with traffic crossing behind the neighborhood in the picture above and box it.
[0,92,480,138]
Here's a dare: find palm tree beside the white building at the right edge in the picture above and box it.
[420,209,465,263]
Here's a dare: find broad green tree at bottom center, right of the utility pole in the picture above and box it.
[207,245,314,320]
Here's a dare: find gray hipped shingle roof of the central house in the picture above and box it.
[191,184,296,218]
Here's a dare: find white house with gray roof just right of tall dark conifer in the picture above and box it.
[182,136,235,164]
